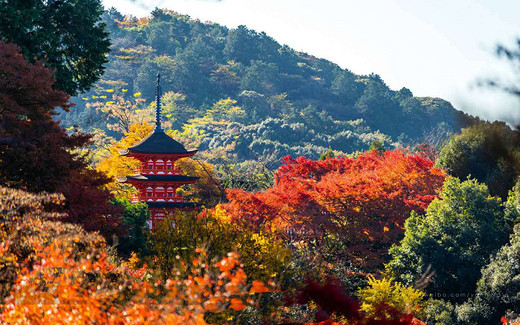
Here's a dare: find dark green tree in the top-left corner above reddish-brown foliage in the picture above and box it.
[0,0,110,96]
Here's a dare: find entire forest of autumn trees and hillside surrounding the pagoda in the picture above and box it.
[0,0,520,325]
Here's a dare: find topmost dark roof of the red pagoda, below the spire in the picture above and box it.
[119,128,197,156]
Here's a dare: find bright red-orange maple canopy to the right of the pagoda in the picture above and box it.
[223,150,446,265]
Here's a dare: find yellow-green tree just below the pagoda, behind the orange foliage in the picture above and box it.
[149,207,290,280]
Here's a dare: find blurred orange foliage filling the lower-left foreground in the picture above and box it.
[0,187,263,324]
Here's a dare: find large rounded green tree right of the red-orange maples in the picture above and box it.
[388,177,518,301]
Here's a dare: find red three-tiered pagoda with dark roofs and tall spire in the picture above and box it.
[119,74,199,229]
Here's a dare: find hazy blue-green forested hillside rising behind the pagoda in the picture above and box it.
[61,9,473,161]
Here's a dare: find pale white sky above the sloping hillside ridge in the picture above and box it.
[102,0,520,124]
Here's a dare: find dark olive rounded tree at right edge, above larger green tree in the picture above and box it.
[437,122,520,200]
